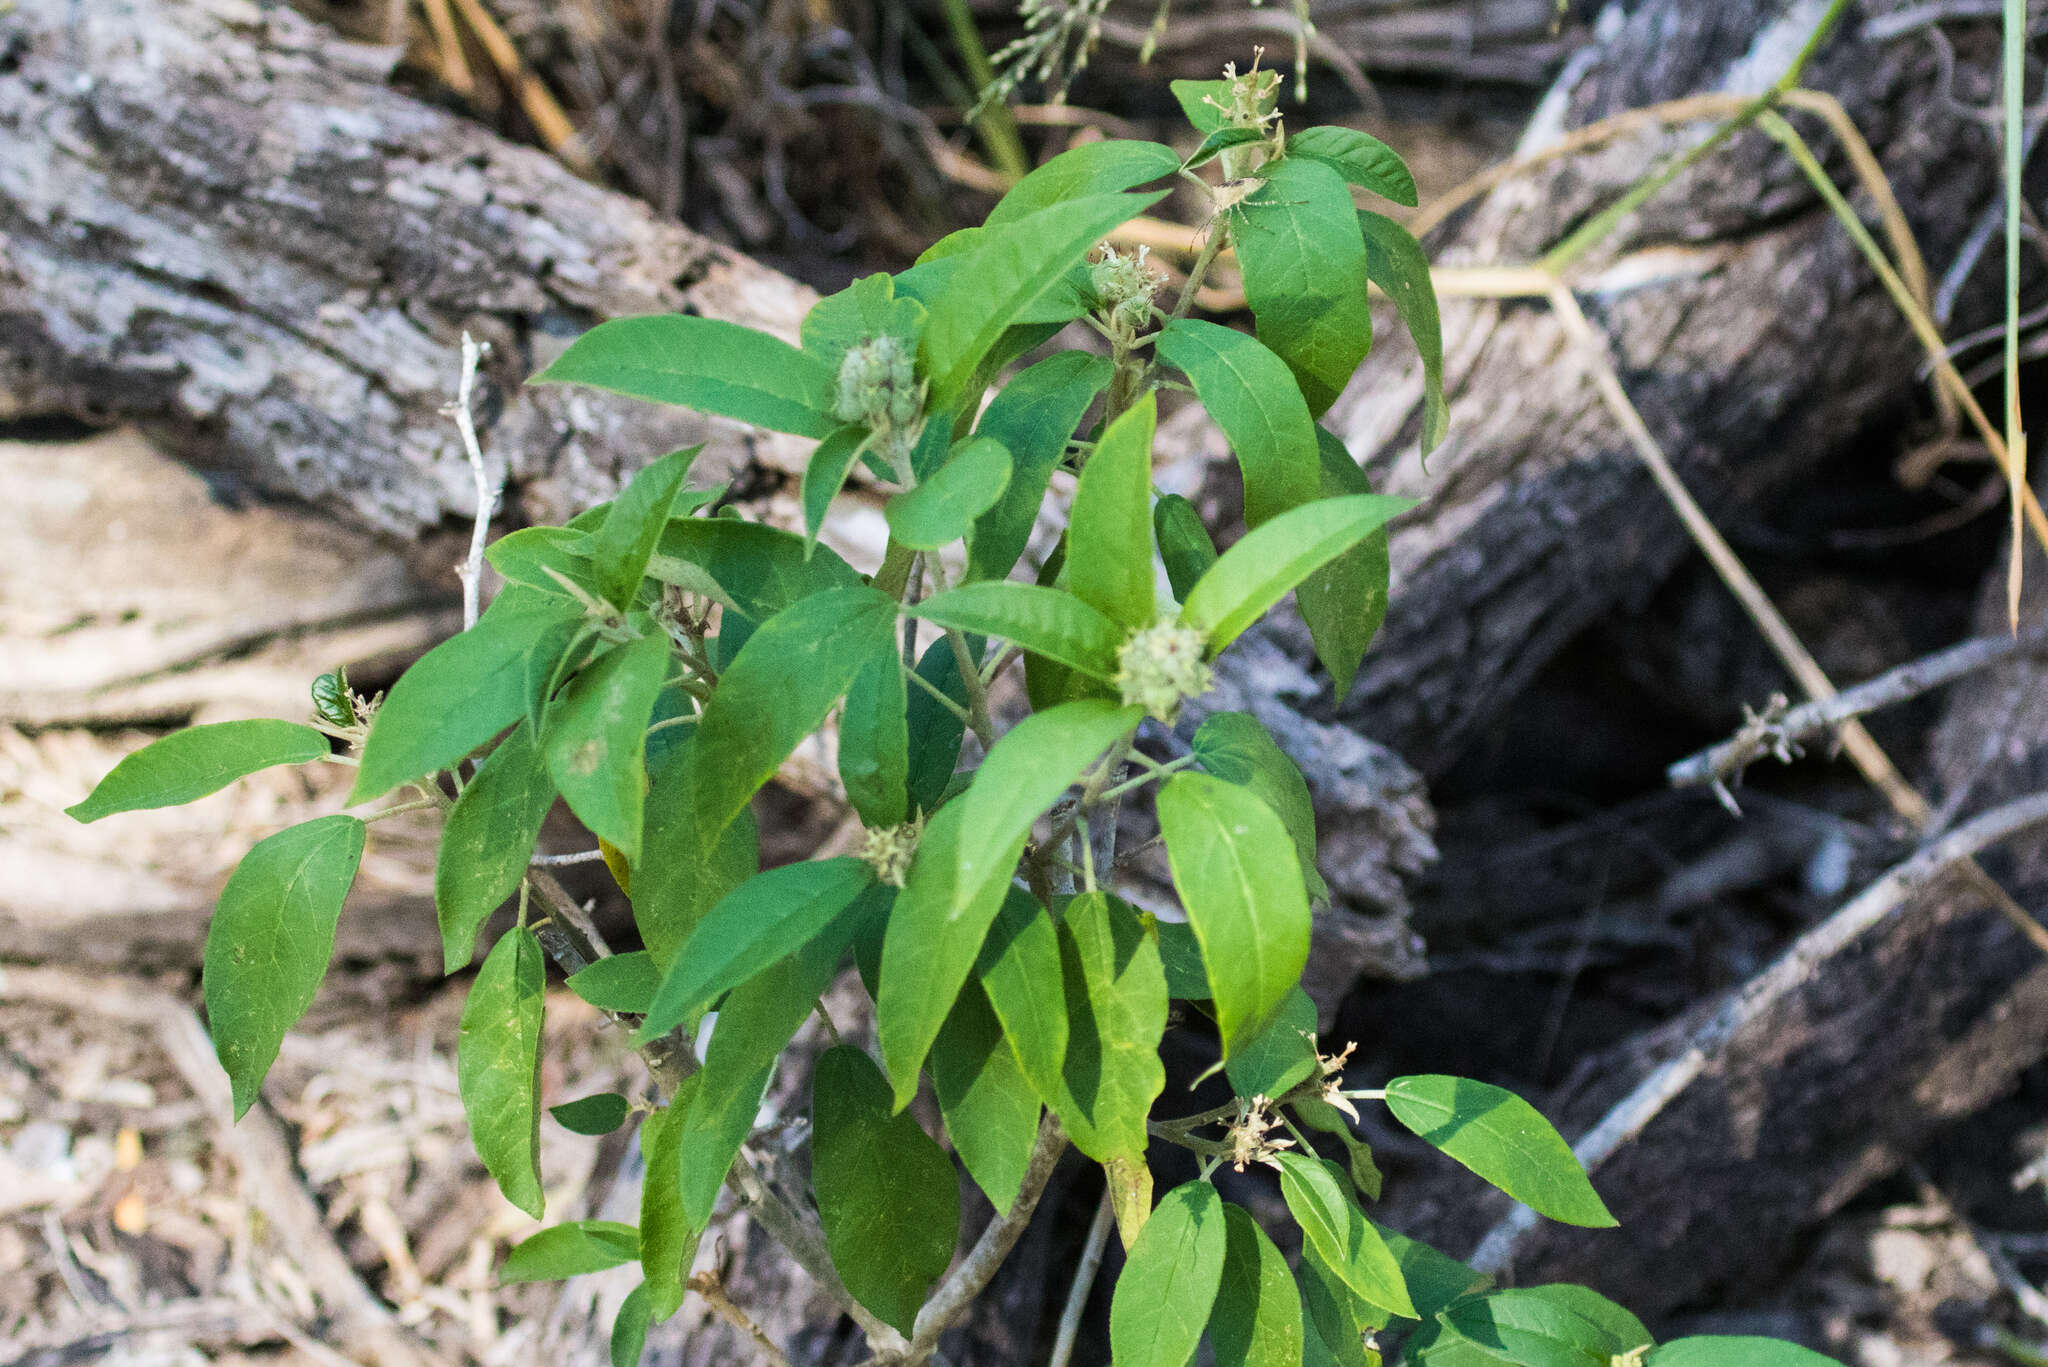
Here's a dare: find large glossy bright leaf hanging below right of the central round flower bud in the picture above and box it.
[1159,773,1309,1058]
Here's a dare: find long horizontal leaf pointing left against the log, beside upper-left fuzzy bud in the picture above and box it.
[526,314,838,437]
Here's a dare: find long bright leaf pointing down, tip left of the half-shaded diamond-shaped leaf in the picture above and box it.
[874,801,1024,1107]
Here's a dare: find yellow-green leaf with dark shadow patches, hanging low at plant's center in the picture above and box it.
[1055,892,1167,1166]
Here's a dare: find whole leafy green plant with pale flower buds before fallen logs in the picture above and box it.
[72,61,1851,1367]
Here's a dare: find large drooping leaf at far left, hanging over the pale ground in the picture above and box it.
[201,816,365,1119]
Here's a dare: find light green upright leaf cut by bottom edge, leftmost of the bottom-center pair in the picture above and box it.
[1110,1183,1229,1367]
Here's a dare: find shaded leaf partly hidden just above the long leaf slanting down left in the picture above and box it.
[633,726,760,969]
